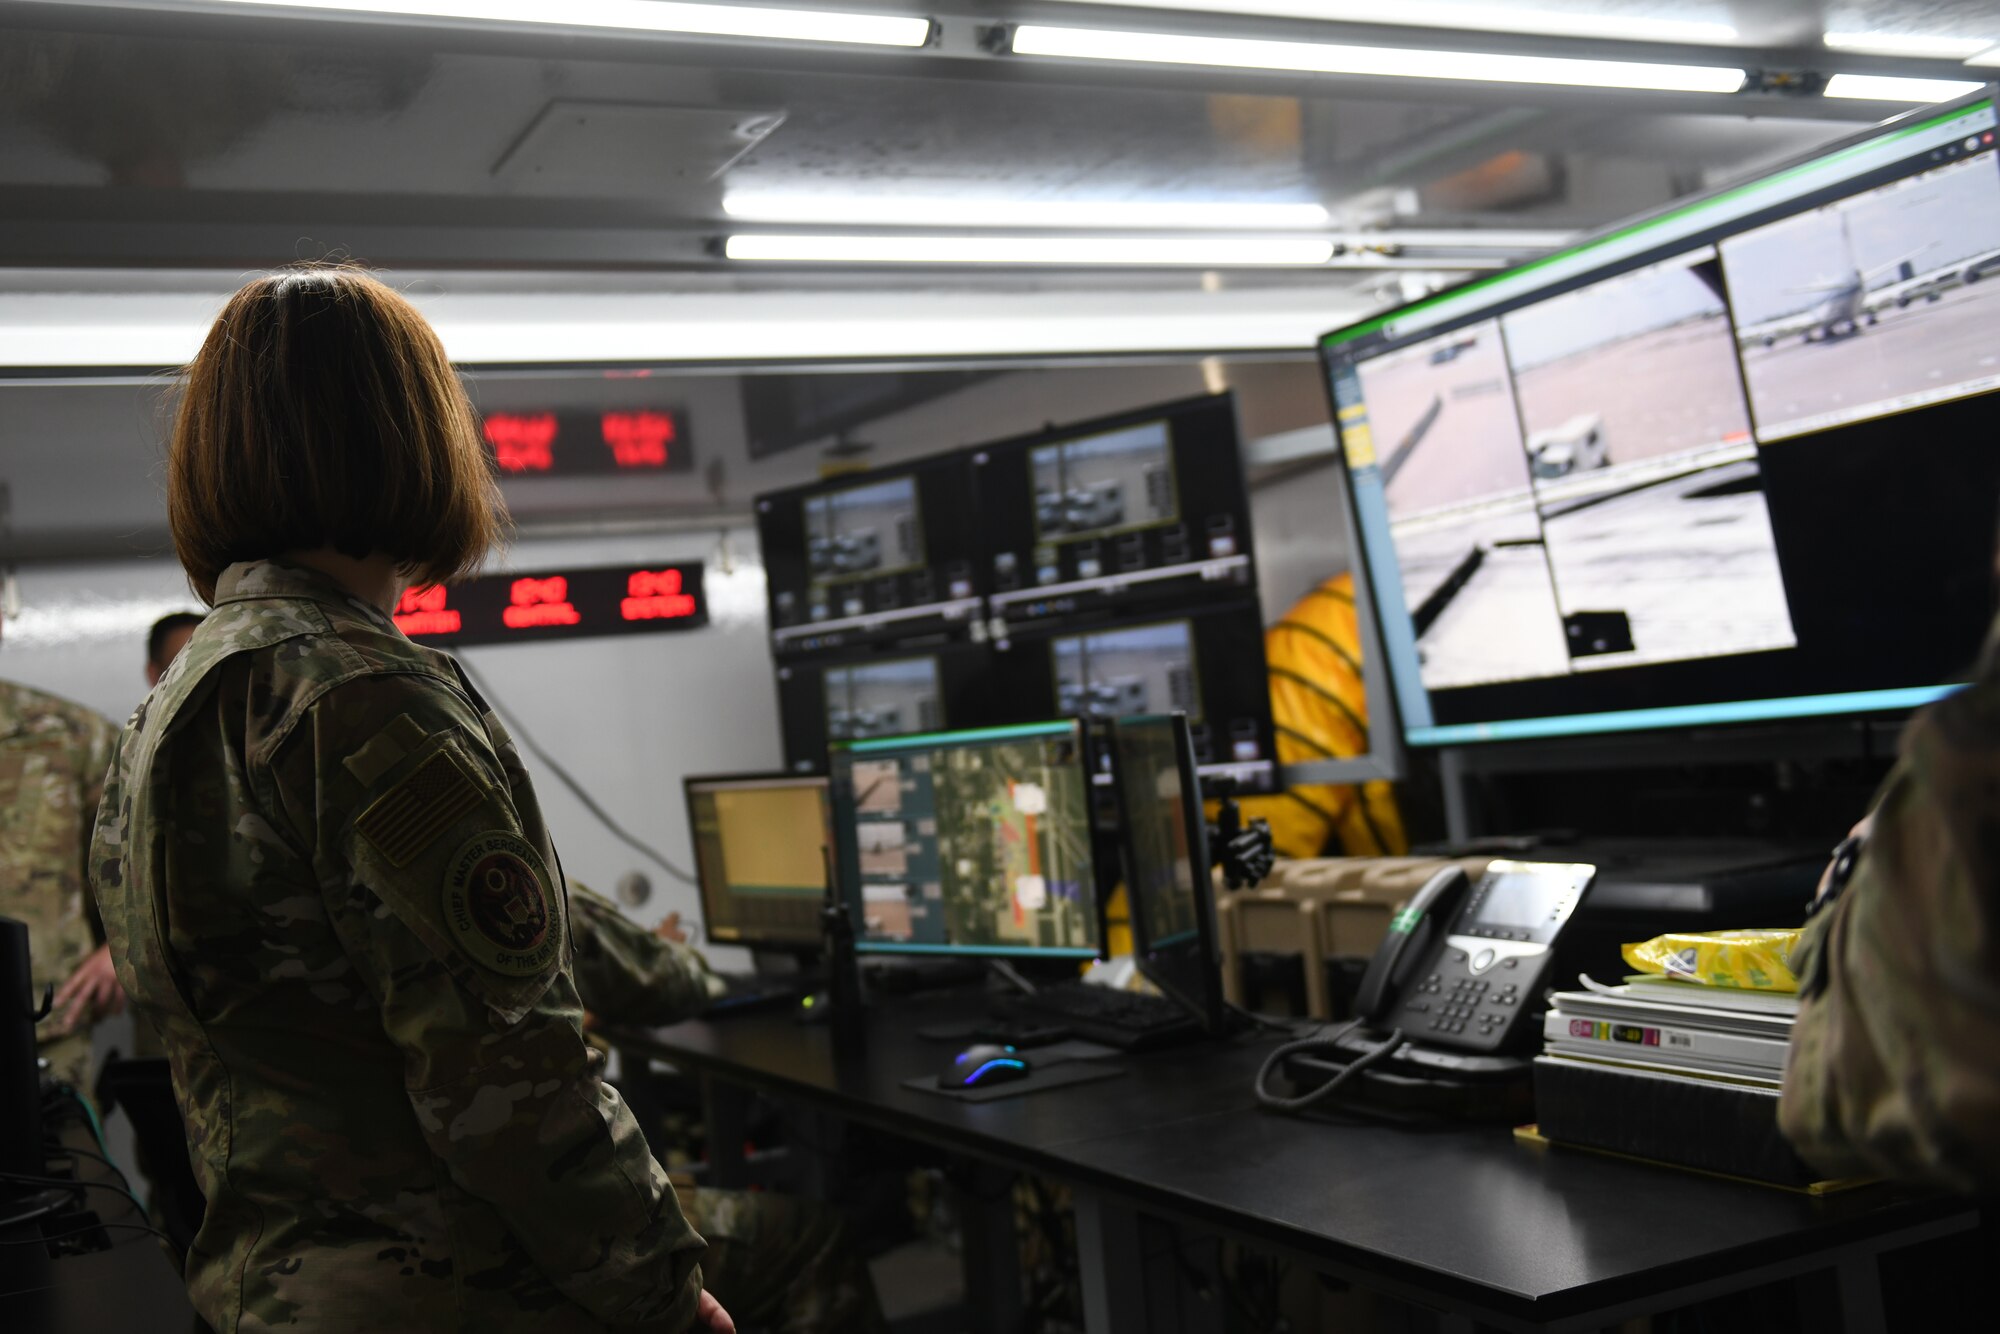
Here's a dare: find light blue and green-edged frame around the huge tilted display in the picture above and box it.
[1314,80,2000,752]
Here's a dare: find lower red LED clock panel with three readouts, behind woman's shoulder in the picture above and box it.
[396,560,708,644]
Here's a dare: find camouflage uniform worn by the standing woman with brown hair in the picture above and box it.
[92,562,702,1334]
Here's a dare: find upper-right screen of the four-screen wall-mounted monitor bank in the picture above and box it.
[968,394,1256,624]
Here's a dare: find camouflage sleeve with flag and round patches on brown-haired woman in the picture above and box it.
[268,676,702,1332]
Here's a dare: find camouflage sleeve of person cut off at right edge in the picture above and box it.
[1780,626,2000,1190]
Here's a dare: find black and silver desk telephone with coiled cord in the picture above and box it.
[1258,862,1596,1110]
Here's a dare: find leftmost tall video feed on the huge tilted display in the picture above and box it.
[1356,320,1570,690]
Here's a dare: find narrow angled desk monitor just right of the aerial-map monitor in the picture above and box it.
[1112,714,1224,1032]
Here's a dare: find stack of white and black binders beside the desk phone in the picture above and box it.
[1534,978,1812,1186]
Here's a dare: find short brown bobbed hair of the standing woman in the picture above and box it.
[166,264,506,602]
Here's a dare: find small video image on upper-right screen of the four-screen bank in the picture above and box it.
[1030,422,1180,542]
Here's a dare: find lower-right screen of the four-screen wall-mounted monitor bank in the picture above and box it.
[992,602,1276,790]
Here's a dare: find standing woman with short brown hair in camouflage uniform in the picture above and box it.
[90,266,734,1334]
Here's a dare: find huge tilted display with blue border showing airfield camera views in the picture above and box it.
[1322,96,2000,746]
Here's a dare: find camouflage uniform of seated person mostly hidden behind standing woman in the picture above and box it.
[570,880,888,1334]
